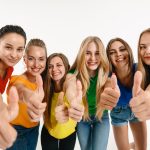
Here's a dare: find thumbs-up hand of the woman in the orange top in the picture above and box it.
[23,75,46,122]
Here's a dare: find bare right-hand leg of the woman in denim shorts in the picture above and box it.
[130,122,147,150]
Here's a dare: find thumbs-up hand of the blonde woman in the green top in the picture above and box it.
[68,80,84,122]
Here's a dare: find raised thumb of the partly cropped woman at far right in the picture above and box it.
[132,71,142,97]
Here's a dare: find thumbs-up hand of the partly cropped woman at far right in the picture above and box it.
[130,71,150,121]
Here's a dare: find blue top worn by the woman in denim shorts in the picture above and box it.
[117,64,136,106]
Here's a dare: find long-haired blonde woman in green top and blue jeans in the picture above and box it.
[68,36,110,150]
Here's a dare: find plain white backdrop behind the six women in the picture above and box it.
[0,0,150,150]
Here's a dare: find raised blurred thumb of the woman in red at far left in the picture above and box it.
[8,86,19,121]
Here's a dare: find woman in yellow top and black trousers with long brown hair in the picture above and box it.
[41,53,76,150]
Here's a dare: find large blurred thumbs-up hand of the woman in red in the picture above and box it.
[0,86,19,149]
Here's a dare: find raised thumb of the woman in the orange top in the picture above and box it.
[36,75,44,101]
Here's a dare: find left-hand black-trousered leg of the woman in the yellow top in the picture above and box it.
[41,126,58,150]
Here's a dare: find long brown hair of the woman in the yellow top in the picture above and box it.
[43,53,70,126]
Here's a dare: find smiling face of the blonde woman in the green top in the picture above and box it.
[85,42,100,75]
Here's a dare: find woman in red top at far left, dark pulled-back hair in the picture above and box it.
[0,25,26,149]
